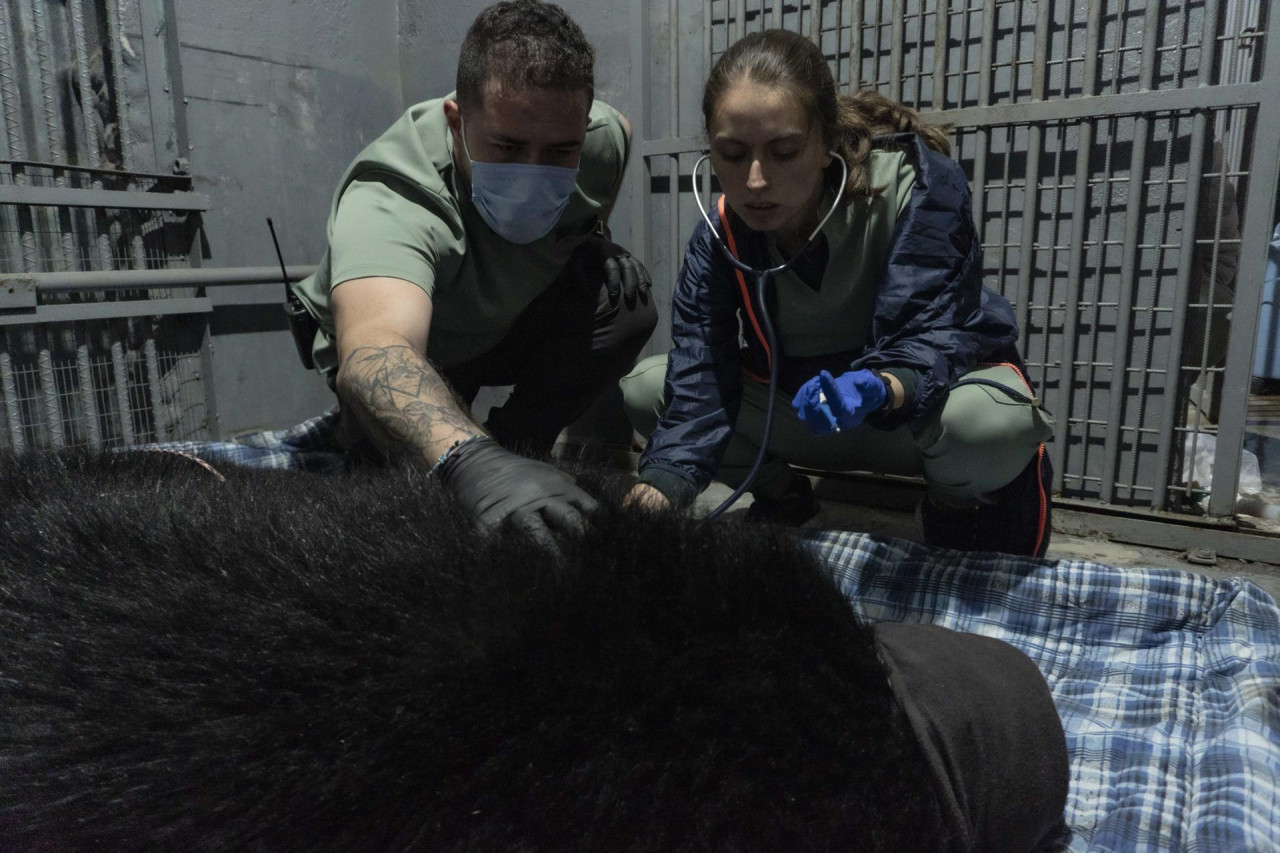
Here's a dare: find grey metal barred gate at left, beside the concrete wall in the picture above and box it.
[0,0,218,450]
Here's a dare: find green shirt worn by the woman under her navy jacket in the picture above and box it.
[769,150,915,356]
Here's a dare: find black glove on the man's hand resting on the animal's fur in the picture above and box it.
[436,437,596,548]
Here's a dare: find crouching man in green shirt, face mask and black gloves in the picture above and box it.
[297,0,657,539]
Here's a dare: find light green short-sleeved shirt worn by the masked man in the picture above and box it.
[294,95,628,373]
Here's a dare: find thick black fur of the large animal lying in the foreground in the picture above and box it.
[0,453,942,850]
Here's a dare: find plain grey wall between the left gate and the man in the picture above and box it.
[175,0,402,427]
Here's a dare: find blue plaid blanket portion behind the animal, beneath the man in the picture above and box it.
[136,406,349,474]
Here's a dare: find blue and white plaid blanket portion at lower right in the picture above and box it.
[808,532,1280,853]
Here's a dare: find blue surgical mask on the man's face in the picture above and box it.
[462,122,577,245]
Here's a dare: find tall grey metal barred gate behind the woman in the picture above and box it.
[632,0,1280,545]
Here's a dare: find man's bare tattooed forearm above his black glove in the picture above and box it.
[338,346,483,456]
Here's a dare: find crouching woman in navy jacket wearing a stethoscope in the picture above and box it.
[622,31,1052,556]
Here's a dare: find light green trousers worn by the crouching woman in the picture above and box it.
[620,356,1053,508]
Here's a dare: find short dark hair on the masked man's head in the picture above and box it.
[457,0,595,105]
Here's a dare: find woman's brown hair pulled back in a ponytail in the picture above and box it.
[703,29,951,197]
